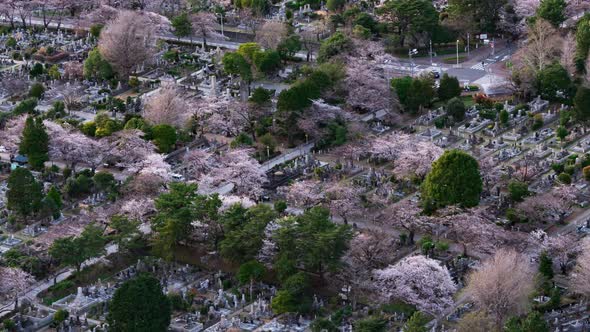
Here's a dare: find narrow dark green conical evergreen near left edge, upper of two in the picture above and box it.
[19,116,49,169]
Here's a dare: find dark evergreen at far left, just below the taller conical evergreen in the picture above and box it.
[6,167,43,217]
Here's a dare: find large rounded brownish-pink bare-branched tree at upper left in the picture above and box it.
[98,11,155,79]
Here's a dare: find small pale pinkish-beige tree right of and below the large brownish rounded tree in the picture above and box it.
[143,83,191,128]
